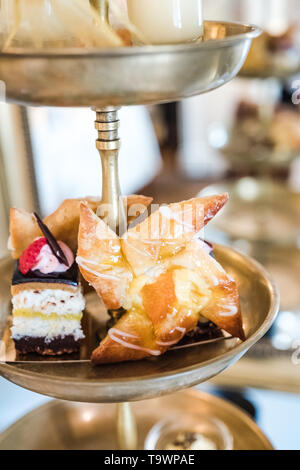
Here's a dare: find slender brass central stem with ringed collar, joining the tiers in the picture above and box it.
[95,107,137,450]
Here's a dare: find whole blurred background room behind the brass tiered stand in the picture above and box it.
[0,0,300,449]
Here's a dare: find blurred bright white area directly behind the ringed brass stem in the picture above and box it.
[29,107,161,214]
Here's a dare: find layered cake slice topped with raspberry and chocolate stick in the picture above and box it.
[11,214,85,355]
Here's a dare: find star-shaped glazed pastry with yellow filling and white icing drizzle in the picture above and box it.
[77,194,245,364]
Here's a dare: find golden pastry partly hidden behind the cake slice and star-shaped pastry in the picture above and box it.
[10,194,152,259]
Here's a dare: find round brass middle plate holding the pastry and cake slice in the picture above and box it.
[0,246,279,403]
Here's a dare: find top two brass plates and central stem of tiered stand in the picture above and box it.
[0,22,278,449]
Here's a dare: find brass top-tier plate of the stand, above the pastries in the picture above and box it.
[0,21,261,107]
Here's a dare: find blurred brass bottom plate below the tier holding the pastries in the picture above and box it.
[0,390,272,450]
